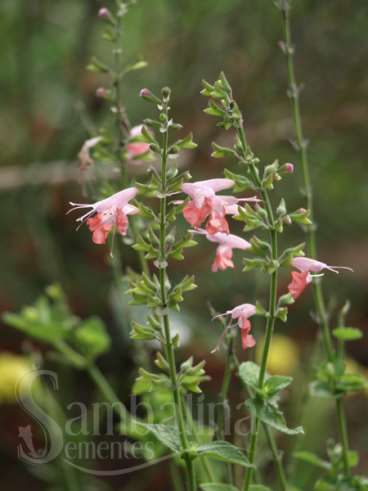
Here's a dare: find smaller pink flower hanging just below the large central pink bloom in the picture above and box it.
[193,229,251,273]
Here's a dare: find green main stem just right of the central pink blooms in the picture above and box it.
[238,126,286,491]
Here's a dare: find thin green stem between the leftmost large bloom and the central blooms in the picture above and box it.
[158,98,196,491]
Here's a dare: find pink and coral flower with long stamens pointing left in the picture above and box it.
[68,187,139,244]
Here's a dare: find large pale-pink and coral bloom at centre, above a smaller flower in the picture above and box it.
[181,179,258,234]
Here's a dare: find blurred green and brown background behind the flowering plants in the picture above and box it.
[0,0,368,489]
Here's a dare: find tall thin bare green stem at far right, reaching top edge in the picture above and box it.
[281,5,351,477]
